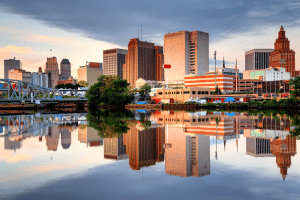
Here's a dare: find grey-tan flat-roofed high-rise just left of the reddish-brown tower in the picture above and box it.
[103,48,128,78]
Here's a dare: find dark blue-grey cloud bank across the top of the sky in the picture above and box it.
[0,0,300,46]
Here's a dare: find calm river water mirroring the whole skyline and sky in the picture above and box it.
[0,110,300,199]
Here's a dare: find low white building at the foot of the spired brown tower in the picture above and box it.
[243,67,291,81]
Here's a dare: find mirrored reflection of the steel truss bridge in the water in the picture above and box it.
[0,113,86,137]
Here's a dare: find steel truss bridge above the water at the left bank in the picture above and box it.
[0,79,87,102]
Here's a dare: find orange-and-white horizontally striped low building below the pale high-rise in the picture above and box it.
[184,75,236,94]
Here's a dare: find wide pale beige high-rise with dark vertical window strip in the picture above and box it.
[164,31,209,81]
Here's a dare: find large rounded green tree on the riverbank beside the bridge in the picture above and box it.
[85,75,134,107]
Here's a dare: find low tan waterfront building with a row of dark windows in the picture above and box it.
[152,87,210,103]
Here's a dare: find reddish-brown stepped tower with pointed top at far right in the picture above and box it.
[270,26,295,77]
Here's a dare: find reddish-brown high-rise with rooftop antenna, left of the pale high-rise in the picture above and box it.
[123,38,163,87]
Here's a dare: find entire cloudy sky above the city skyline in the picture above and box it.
[0,0,300,78]
